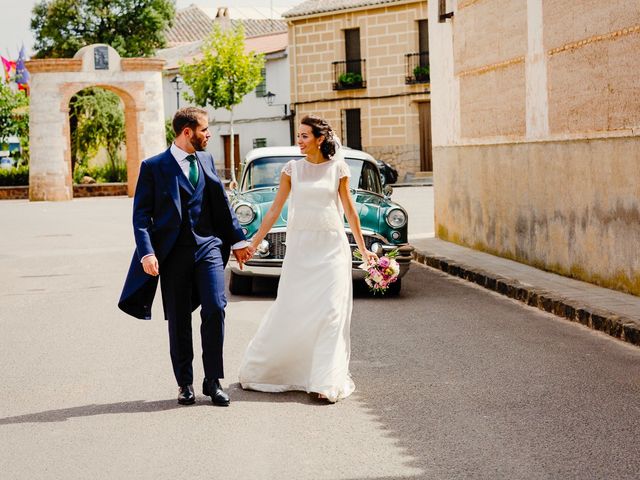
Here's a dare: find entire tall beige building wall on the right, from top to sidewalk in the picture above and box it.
[429,0,640,295]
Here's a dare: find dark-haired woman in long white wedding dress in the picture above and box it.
[239,115,376,403]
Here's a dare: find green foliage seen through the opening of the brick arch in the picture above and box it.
[69,88,125,178]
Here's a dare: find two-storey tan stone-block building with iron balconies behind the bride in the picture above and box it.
[283,0,431,179]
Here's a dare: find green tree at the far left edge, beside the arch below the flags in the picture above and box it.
[0,82,29,164]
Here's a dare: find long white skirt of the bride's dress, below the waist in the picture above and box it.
[239,231,355,402]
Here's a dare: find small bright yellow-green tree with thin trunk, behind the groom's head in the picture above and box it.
[180,25,264,182]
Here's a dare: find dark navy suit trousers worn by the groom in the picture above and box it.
[160,245,227,386]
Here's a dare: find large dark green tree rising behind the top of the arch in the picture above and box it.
[31,0,175,58]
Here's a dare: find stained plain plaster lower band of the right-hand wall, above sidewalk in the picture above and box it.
[434,137,640,295]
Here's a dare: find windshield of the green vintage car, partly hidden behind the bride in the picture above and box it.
[241,156,382,194]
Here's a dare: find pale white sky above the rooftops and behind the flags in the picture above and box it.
[0,0,304,60]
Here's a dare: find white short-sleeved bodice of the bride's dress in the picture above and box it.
[282,159,351,231]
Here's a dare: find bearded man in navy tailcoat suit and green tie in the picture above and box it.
[118,107,253,406]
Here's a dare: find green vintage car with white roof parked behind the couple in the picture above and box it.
[229,147,413,295]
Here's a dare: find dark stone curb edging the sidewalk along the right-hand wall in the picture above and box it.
[413,251,640,346]
